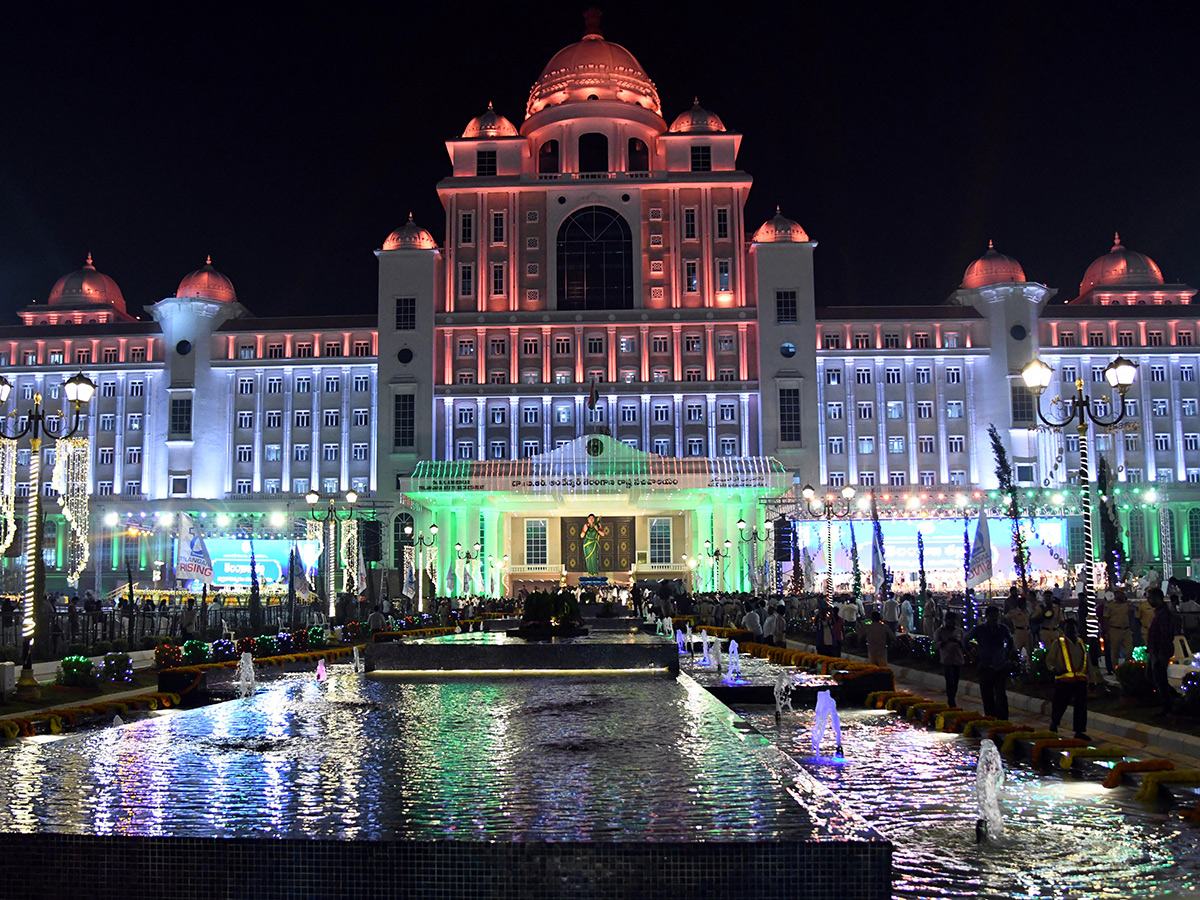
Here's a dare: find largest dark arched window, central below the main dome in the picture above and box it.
[558,206,634,310]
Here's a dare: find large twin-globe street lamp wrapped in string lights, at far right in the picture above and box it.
[1021,356,1138,647]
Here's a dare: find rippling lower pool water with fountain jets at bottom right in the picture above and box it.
[739,707,1200,900]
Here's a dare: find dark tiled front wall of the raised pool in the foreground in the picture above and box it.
[4,834,892,900]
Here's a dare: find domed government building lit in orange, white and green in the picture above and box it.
[0,22,1200,594]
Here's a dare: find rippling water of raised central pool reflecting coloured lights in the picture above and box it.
[0,670,866,841]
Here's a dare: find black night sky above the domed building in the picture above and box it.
[0,2,1200,324]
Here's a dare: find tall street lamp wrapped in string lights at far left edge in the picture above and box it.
[0,372,96,700]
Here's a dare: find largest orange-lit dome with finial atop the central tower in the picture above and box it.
[526,10,662,119]
